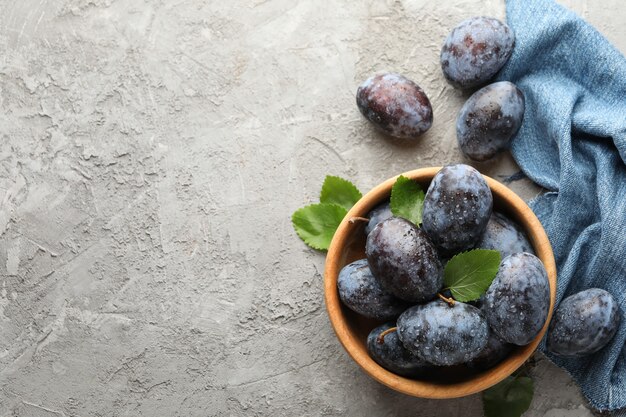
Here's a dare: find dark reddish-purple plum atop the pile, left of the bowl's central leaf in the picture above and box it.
[365,217,443,302]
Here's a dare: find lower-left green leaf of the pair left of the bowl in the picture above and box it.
[291,203,348,250]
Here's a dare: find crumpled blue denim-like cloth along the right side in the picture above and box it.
[498,0,626,415]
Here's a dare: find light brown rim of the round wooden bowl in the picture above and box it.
[324,167,556,399]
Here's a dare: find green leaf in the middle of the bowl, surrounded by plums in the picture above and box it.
[443,249,500,303]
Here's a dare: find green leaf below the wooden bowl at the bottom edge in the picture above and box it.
[483,376,534,417]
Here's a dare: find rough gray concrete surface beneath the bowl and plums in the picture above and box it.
[0,0,626,417]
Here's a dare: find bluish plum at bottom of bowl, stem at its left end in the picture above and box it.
[398,300,489,366]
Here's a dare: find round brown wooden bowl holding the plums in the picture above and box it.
[324,167,556,399]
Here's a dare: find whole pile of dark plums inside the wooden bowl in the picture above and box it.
[337,164,550,377]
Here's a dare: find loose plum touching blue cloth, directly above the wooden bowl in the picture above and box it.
[456,81,524,162]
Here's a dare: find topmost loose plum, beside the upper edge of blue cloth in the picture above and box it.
[440,16,515,89]
